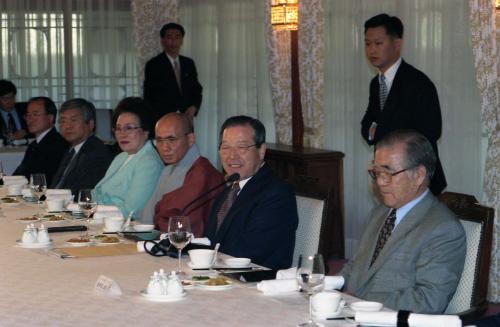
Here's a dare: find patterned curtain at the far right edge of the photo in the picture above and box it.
[469,0,500,302]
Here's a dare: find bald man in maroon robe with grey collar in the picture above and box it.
[141,112,224,237]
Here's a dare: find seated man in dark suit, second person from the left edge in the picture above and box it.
[14,97,68,185]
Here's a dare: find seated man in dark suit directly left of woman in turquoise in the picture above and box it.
[51,99,113,195]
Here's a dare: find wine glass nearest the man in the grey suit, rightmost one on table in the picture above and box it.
[297,254,325,327]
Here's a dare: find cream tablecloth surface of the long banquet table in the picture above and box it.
[0,189,362,327]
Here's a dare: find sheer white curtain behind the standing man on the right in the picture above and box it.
[324,0,482,257]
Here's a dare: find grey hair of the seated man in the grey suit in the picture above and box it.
[376,130,437,182]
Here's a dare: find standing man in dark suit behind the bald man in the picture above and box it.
[144,23,203,120]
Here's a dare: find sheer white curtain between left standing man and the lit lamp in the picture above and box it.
[179,0,275,163]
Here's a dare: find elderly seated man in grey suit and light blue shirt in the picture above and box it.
[339,130,466,313]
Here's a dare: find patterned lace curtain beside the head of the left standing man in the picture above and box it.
[129,0,178,85]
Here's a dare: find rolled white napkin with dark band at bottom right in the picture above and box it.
[354,311,462,327]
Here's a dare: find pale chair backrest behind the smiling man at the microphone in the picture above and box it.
[292,195,327,266]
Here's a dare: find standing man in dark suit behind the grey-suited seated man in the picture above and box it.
[361,14,447,195]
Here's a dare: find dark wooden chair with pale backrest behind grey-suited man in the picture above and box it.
[439,192,494,320]
